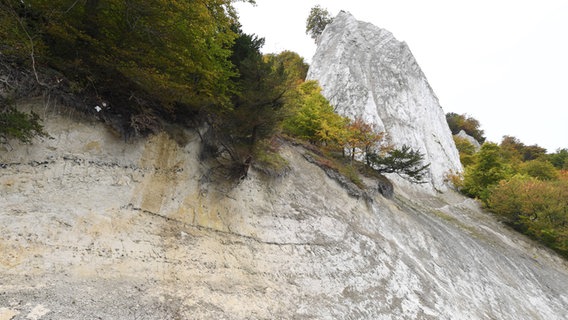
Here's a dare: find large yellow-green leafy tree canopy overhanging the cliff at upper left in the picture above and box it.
[0,0,246,115]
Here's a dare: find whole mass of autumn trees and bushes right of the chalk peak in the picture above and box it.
[447,113,568,257]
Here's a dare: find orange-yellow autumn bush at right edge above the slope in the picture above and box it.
[487,175,568,258]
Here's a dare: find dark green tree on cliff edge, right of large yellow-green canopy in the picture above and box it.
[203,26,291,168]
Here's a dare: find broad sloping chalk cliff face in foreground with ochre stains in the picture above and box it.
[0,105,568,320]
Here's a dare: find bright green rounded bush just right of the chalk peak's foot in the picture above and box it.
[461,142,511,202]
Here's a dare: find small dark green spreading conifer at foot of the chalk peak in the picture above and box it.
[366,145,430,183]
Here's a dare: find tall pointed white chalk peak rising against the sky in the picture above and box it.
[308,11,462,190]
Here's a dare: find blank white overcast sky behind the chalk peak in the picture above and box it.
[235,0,568,152]
